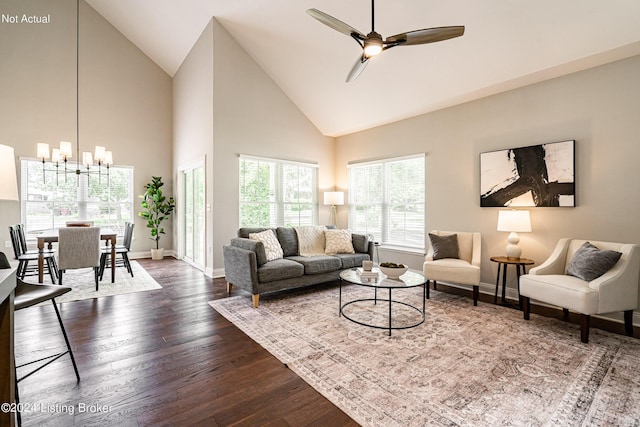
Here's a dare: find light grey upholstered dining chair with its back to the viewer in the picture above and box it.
[58,227,100,291]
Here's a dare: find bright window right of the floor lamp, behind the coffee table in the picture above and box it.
[349,155,425,249]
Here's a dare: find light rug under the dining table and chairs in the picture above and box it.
[48,261,162,303]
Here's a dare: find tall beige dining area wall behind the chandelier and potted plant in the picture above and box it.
[0,0,173,253]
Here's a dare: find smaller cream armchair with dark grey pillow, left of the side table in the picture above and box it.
[422,230,481,305]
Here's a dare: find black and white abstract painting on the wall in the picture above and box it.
[480,140,576,207]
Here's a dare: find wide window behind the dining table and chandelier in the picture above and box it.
[21,159,134,235]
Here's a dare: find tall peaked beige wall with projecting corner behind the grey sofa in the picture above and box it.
[174,19,335,275]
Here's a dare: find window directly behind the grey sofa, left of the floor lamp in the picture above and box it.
[239,156,318,227]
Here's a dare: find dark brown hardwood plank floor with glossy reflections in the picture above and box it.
[15,258,357,427]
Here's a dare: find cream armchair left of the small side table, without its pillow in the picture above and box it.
[422,230,481,305]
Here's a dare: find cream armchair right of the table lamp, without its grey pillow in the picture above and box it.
[520,239,640,343]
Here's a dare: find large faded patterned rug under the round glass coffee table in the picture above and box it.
[209,285,640,427]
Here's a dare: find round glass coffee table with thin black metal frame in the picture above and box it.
[338,268,427,336]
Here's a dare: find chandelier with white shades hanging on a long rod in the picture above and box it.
[36,0,113,183]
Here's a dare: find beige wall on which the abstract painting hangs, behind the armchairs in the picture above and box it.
[336,56,640,318]
